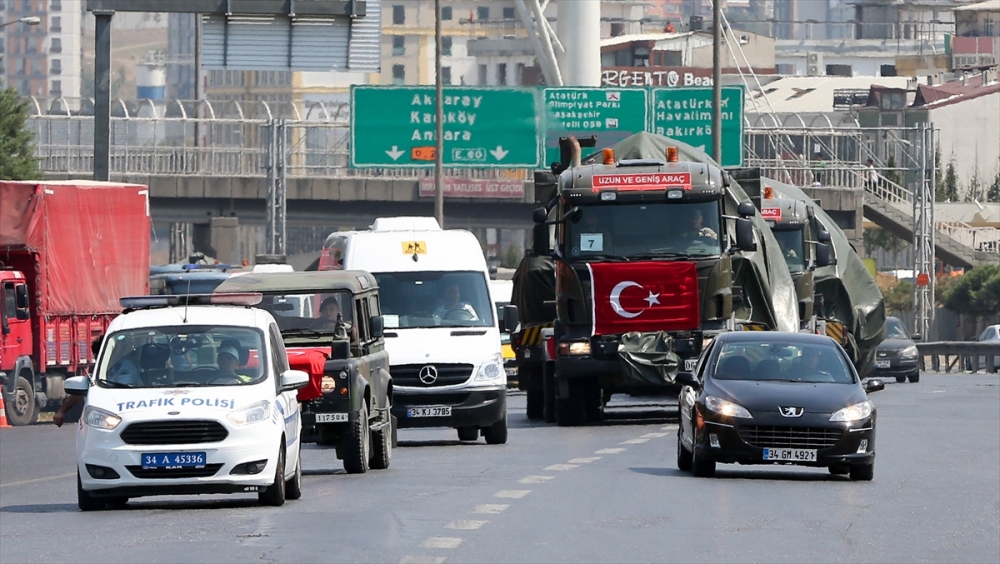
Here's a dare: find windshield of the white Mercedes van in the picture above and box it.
[373,272,493,329]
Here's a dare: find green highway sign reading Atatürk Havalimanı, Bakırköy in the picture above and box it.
[650,86,743,166]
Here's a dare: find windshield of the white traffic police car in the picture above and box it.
[96,325,267,388]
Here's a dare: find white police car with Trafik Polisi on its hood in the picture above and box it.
[66,294,309,511]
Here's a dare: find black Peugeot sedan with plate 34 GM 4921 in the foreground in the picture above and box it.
[677,331,885,480]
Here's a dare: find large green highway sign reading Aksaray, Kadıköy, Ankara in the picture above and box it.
[351,86,539,168]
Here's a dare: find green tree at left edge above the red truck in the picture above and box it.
[0,88,40,180]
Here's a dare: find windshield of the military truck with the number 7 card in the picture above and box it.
[565,202,722,260]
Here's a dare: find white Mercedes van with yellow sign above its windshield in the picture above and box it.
[319,217,517,444]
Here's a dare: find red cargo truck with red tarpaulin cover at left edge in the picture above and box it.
[0,180,150,425]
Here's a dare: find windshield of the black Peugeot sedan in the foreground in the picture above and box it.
[712,342,854,384]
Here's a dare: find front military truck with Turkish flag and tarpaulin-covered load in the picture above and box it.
[514,133,798,425]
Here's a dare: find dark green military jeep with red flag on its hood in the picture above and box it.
[215,270,396,474]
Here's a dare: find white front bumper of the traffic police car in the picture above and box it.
[77,419,286,497]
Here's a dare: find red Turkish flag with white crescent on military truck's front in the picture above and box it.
[587,262,701,335]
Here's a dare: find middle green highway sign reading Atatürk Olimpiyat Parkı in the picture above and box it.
[542,87,649,166]
